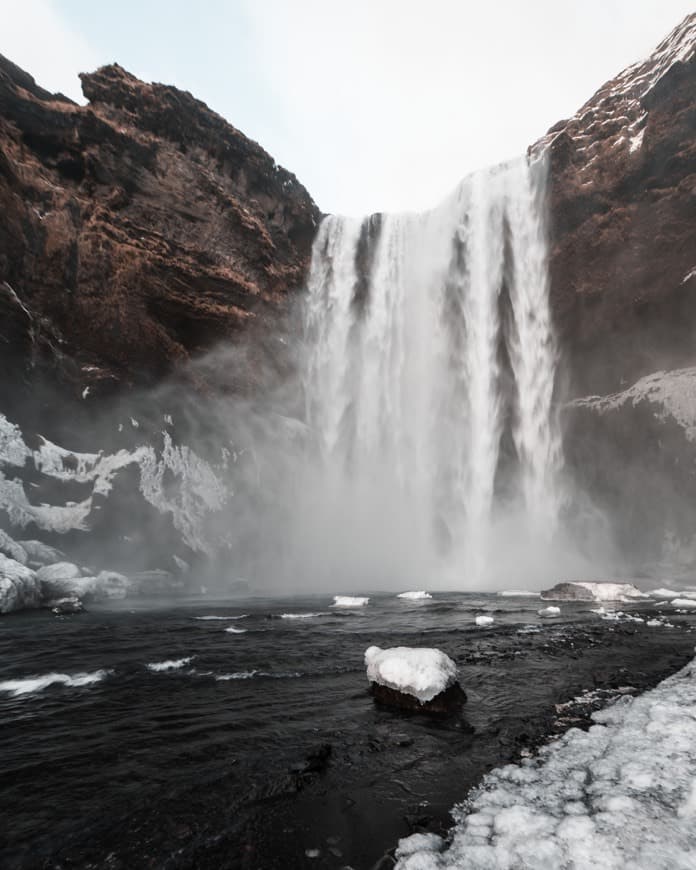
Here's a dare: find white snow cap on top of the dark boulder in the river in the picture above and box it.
[365,646,457,704]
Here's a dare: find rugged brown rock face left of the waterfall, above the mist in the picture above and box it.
[0,56,319,410]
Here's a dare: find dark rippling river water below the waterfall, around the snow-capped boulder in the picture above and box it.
[0,594,693,870]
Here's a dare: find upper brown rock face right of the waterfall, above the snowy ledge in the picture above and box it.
[533,14,696,395]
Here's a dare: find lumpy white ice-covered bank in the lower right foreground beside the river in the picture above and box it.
[396,661,696,870]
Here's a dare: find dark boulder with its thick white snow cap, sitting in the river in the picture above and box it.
[365,646,466,715]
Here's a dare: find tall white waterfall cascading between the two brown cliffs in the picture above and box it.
[304,159,561,587]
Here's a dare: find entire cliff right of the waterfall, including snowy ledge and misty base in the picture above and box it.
[534,14,696,577]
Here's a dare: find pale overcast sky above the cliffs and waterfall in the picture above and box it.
[0,0,693,214]
